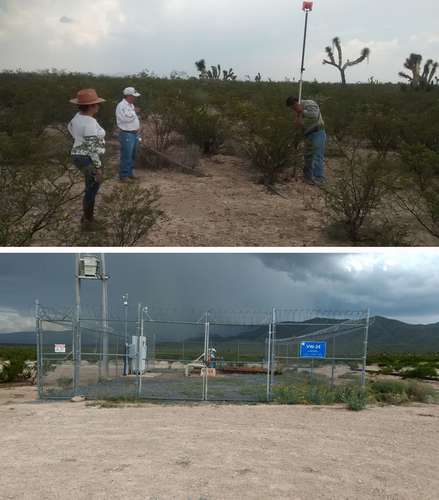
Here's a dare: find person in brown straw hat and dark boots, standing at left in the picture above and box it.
[68,89,105,230]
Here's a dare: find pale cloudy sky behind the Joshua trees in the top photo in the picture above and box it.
[0,0,439,82]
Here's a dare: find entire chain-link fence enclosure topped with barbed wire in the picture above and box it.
[36,306,369,401]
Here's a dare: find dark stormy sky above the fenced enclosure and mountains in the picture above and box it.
[0,249,439,332]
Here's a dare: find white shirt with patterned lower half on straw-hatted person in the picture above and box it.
[67,113,105,167]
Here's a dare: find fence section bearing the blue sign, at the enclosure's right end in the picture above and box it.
[270,311,368,399]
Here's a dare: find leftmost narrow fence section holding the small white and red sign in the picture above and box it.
[37,321,75,399]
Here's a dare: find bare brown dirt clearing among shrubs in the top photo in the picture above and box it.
[107,148,330,247]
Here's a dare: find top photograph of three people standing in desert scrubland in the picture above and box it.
[0,0,439,248]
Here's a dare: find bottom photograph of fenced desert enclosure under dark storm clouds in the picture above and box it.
[0,249,439,500]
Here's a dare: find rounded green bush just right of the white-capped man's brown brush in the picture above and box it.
[177,104,226,155]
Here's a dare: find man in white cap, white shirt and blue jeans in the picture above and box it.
[116,87,140,182]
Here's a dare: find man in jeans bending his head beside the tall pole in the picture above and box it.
[287,96,326,184]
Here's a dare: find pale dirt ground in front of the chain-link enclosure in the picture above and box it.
[0,387,439,500]
